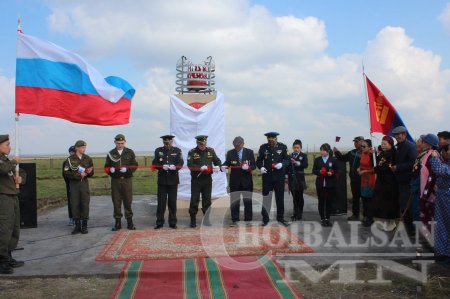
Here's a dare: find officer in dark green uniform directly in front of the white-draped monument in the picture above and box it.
[188,135,222,228]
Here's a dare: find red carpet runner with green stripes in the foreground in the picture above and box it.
[112,256,303,299]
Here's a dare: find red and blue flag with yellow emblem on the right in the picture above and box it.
[364,75,414,141]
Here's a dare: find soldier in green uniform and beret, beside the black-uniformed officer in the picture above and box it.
[105,134,138,231]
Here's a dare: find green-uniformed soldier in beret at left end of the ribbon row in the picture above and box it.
[64,140,94,235]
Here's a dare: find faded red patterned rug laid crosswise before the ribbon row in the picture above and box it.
[96,224,313,261]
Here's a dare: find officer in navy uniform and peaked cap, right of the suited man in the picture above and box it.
[256,132,290,226]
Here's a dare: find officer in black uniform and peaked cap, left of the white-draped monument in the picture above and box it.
[152,135,184,229]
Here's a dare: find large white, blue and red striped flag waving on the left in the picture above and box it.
[16,32,135,126]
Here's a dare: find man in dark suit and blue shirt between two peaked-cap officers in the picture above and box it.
[222,136,256,226]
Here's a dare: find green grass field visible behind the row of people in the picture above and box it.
[22,154,349,206]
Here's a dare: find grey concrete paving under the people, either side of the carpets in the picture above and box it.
[5,193,424,278]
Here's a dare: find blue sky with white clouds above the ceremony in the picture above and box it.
[0,0,450,155]
